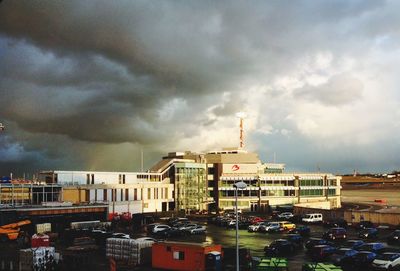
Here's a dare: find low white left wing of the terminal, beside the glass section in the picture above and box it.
[39,171,174,214]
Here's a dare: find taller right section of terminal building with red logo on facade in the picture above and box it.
[155,148,341,211]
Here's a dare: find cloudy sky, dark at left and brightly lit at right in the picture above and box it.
[0,0,400,176]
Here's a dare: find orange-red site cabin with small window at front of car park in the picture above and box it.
[152,242,222,271]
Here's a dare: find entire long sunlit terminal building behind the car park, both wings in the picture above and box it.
[40,148,341,213]
